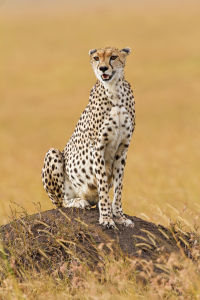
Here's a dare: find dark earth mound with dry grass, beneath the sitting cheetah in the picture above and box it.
[0,208,190,272]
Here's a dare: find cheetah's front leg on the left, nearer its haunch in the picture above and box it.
[93,150,115,228]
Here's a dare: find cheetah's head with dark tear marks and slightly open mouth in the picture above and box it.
[89,47,131,84]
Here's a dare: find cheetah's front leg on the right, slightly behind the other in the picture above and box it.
[112,143,134,227]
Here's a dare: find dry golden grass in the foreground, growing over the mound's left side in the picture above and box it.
[0,203,200,300]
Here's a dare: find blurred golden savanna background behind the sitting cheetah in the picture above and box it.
[0,0,200,225]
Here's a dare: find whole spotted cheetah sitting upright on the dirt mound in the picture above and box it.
[42,47,135,228]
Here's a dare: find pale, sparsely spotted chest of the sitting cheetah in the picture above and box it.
[104,105,132,176]
